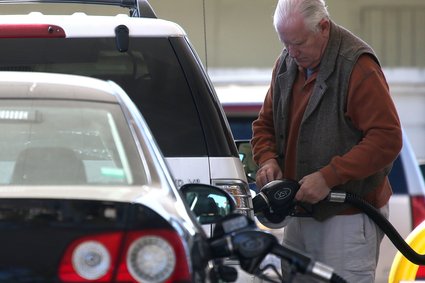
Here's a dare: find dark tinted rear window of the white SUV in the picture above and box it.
[0,36,207,157]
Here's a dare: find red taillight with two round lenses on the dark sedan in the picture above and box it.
[59,230,191,282]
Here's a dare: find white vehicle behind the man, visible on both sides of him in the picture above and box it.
[217,89,425,283]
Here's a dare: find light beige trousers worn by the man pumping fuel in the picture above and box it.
[282,205,389,283]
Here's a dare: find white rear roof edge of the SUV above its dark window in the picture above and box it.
[0,12,186,38]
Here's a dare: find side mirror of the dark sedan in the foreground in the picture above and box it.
[180,184,236,224]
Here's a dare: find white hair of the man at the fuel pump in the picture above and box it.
[273,0,329,33]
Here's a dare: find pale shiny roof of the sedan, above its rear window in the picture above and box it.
[0,71,117,102]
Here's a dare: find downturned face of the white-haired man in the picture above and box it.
[278,16,330,68]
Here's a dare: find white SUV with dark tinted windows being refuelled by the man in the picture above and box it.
[0,0,253,219]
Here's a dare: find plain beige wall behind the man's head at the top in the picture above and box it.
[150,0,425,68]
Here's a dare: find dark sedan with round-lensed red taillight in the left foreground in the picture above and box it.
[0,72,219,282]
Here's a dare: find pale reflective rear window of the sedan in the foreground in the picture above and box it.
[0,100,146,185]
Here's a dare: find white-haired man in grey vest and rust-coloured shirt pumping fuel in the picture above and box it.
[251,0,402,283]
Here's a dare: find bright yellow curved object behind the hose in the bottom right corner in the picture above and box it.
[388,221,425,283]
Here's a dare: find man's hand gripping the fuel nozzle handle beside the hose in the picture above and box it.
[295,172,331,204]
